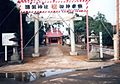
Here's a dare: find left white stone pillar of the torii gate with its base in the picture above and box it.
[32,14,40,57]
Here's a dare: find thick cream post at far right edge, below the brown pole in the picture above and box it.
[113,34,119,60]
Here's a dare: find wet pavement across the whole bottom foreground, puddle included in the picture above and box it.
[0,64,120,84]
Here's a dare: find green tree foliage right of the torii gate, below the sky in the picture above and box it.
[74,12,113,46]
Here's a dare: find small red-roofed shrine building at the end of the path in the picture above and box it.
[45,28,63,45]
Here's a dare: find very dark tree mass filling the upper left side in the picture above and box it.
[0,0,33,59]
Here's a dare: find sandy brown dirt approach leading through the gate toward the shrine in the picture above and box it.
[0,45,114,73]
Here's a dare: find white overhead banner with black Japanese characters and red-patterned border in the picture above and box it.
[18,0,90,13]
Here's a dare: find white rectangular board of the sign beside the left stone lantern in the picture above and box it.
[2,33,16,46]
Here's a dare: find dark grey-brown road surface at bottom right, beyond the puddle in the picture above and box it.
[30,64,120,84]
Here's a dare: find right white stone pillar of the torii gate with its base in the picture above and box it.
[70,19,77,55]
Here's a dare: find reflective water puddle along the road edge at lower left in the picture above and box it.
[0,69,75,82]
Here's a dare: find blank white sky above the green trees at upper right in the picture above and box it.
[13,0,116,25]
